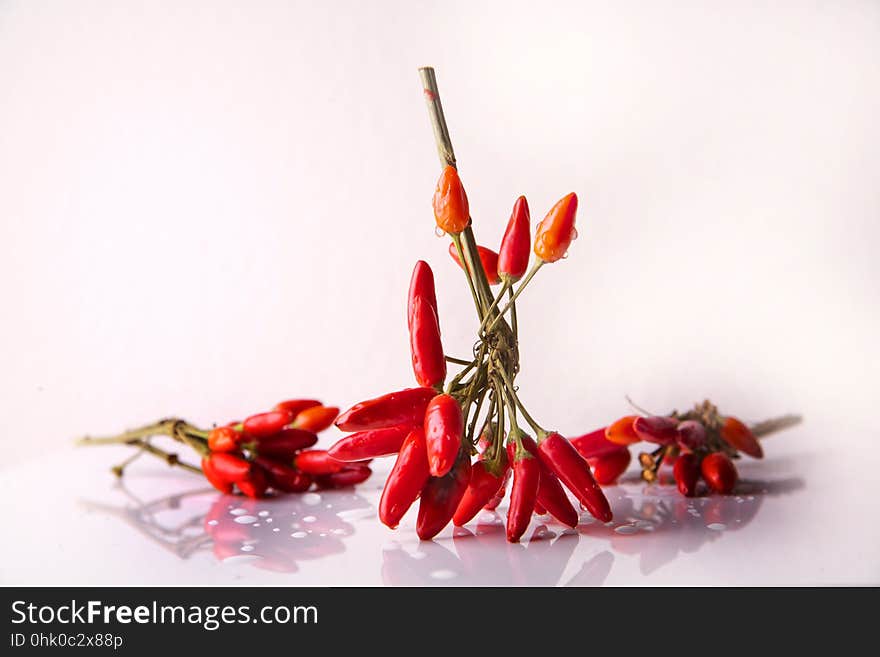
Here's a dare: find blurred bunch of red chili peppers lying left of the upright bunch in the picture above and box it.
[74,399,372,498]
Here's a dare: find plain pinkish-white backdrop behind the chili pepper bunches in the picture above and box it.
[0,0,880,582]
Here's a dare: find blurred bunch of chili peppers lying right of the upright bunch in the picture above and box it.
[571,400,799,497]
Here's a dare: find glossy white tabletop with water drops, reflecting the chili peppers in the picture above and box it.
[0,428,880,586]
